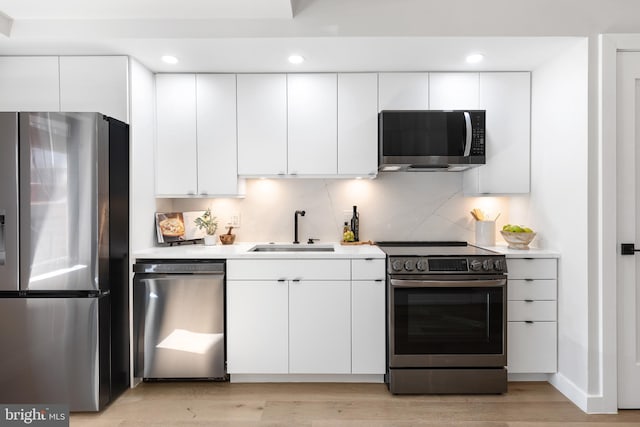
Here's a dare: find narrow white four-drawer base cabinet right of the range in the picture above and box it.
[507,257,558,374]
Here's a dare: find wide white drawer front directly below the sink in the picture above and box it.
[227,259,351,280]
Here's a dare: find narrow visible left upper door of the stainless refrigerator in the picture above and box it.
[0,113,18,291]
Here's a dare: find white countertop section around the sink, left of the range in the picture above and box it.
[133,242,385,259]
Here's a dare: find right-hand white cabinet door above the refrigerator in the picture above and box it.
[60,56,129,123]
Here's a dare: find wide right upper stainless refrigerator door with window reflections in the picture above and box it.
[19,113,109,291]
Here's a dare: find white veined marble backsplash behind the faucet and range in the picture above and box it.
[168,172,509,246]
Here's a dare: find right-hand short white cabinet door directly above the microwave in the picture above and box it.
[429,73,480,110]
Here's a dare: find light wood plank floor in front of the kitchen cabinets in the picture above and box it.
[70,382,640,427]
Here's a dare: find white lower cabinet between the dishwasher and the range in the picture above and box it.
[227,259,385,375]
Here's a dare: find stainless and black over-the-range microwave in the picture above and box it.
[378,110,485,171]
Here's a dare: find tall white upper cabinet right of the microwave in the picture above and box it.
[463,72,531,195]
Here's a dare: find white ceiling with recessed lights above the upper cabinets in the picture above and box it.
[0,0,640,72]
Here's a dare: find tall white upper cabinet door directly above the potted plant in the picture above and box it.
[196,74,238,196]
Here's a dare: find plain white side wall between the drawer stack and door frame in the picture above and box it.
[511,39,590,404]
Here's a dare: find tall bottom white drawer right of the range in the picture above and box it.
[507,322,558,373]
